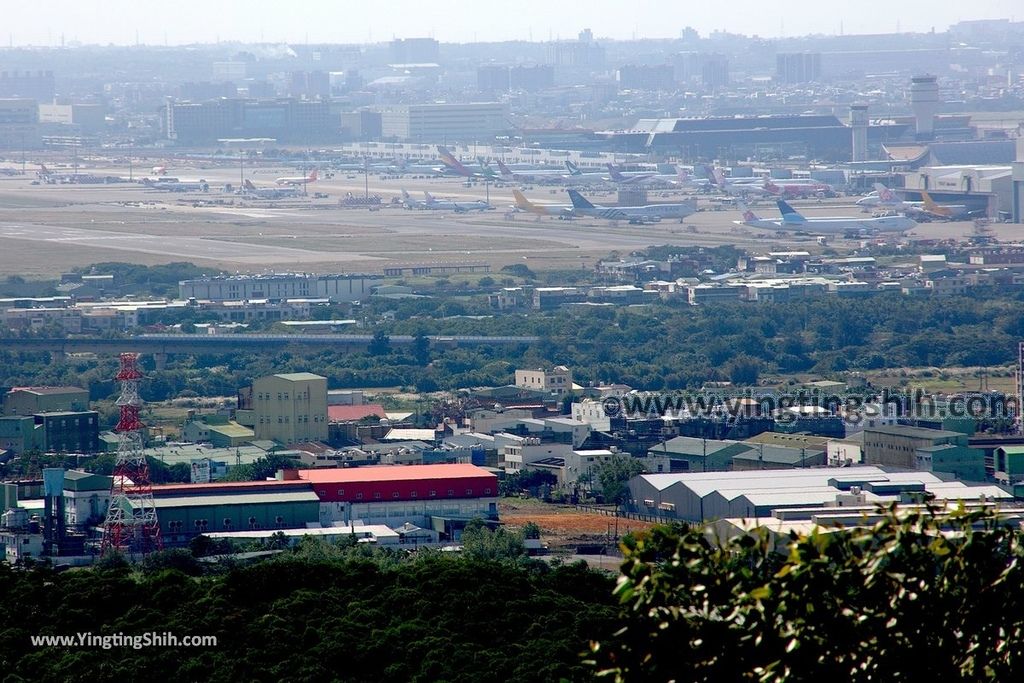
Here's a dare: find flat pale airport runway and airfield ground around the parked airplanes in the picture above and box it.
[0,162,999,274]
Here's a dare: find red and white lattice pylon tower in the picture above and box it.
[102,353,161,556]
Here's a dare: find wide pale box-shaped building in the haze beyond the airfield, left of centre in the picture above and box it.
[377,102,510,143]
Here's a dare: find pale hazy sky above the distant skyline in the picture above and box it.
[0,0,1024,45]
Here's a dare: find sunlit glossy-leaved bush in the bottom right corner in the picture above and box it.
[592,511,1024,681]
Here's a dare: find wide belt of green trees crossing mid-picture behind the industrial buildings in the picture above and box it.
[0,292,1024,400]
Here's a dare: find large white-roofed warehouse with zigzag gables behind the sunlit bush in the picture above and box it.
[628,466,1013,522]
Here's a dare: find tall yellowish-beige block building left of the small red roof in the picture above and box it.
[252,373,328,443]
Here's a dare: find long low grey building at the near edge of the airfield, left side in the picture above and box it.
[178,272,379,302]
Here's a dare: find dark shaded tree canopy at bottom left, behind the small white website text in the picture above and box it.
[0,543,615,683]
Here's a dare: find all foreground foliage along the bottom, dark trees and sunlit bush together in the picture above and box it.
[6,509,1024,683]
